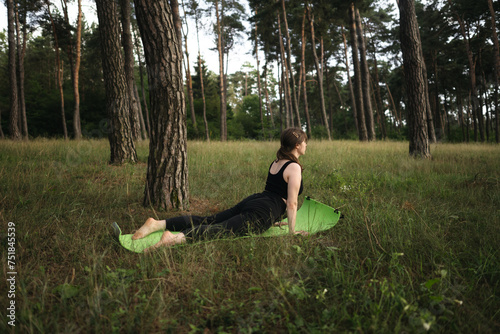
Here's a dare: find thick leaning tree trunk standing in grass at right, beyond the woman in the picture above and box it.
[399,0,431,158]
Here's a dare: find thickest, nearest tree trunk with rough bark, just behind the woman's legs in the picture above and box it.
[134,0,189,210]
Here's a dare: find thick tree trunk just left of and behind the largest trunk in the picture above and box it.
[96,0,137,164]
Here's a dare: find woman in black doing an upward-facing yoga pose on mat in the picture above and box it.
[132,128,307,252]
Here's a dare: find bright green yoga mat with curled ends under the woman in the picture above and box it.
[113,197,340,253]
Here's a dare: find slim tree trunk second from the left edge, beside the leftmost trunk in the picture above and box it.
[15,5,28,140]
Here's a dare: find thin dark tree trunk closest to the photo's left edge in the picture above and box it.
[7,0,21,140]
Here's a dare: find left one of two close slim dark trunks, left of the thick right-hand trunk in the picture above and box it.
[349,3,368,141]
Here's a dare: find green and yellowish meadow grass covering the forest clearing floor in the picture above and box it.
[0,140,500,333]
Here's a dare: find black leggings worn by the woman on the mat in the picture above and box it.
[165,191,286,240]
